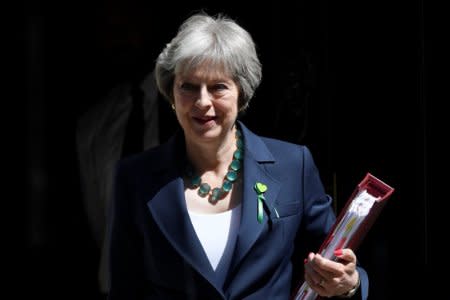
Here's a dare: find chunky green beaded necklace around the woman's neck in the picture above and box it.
[186,129,244,203]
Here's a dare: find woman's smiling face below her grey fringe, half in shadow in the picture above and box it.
[173,67,239,142]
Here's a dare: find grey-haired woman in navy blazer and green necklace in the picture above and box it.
[109,14,368,299]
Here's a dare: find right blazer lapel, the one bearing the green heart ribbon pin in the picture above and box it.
[230,124,280,273]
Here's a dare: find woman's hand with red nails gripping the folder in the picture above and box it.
[305,249,359,297]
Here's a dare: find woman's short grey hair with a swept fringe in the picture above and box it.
[155,13,262,111]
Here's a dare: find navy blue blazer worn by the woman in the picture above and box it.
[109,123,368,300]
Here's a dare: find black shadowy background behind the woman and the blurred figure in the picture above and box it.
[8,0,432,299]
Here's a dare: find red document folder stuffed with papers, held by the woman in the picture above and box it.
[291,173,394,300]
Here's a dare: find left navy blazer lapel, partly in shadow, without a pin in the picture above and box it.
[147,137,222,293]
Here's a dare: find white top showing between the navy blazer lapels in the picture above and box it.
[189,204,241,270]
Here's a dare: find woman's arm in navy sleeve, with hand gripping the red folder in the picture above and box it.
[300,148,368,299]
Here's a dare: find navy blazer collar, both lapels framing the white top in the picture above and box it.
[147,122,280,296]
